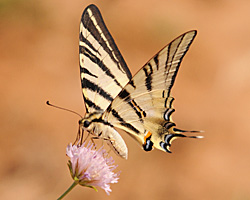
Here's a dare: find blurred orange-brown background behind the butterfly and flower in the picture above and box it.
[0,0,250,200]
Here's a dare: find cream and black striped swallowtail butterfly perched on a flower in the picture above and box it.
[79,4,200,159]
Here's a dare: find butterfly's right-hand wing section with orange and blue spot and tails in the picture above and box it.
[103,31,199,152]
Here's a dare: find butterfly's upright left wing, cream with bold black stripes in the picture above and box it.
[79,5,131,113]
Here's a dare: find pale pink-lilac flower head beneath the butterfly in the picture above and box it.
[66,143,119,194]
